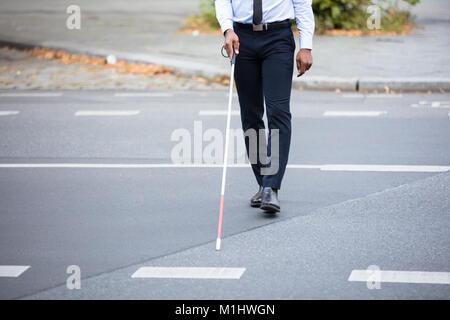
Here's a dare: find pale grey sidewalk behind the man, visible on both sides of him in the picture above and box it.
[0,0,450,90]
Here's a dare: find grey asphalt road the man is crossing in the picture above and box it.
[0,91,450,299]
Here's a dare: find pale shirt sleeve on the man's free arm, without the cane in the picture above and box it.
[292,0,315,49]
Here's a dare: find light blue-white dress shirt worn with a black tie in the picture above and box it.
[215,0,315,49]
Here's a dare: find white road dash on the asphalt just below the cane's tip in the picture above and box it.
[131,267,245,279]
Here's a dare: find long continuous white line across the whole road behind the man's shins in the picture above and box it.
[0,163,450,172]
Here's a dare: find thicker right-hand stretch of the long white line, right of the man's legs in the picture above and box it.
[320,164,450,172]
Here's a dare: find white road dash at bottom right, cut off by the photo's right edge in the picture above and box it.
[348,270,450,284]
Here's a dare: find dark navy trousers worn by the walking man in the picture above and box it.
[234,25,295,189]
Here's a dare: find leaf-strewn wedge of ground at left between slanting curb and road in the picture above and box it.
[0,49,228,91]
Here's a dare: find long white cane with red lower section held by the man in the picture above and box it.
[216,52,236,250]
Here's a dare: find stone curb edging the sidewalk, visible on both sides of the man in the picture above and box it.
[0,40,450,92]
